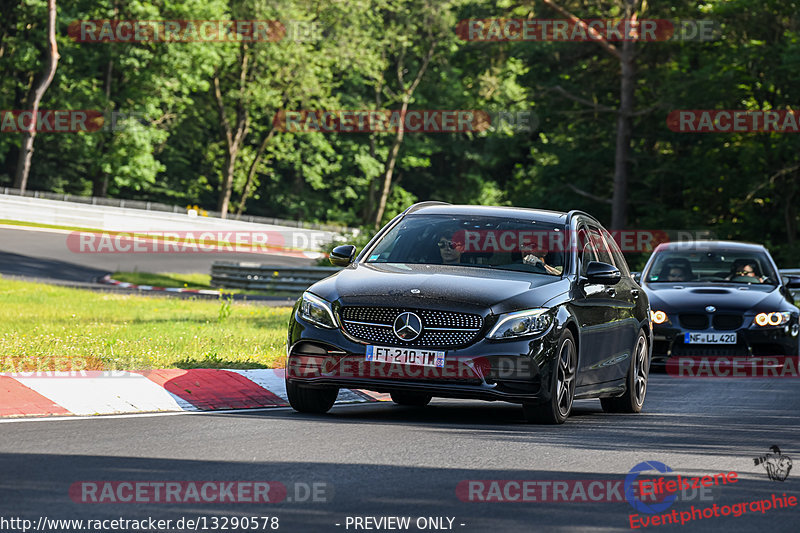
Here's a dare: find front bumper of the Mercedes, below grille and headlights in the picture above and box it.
[286,313,561,403]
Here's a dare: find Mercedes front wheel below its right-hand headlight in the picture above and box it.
[522,329,578,424]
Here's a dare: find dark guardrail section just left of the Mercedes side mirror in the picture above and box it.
[211,261,341,293]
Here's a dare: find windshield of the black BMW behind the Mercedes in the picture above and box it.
[644,250,777,285]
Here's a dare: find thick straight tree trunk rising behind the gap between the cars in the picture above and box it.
[611,35,636,230]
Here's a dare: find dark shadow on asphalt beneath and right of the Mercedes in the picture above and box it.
[202,376,800,454]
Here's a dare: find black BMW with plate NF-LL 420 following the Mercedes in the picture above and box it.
[642,241,800,365]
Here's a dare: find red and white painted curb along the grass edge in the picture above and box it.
[0,368,390,417]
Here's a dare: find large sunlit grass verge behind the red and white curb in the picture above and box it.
[0,278,291,372]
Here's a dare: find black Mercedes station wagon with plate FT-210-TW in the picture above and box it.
[286,202,652,424]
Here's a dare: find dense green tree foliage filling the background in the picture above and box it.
[0,0,800,266]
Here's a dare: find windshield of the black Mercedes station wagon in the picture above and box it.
[367,214,566,276]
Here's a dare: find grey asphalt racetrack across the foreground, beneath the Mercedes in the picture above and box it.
[0,374,800,533]
